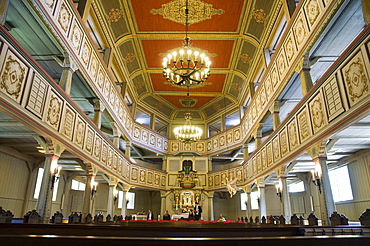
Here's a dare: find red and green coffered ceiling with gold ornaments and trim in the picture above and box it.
[93,0,283,121]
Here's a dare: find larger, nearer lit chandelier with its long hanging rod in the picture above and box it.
[162,1,211,86]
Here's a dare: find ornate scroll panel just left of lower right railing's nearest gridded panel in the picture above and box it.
[308,93,328,133]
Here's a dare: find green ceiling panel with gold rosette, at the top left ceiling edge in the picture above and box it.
[101,0,130,39]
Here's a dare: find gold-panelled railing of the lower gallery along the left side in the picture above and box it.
[0,26,166,189]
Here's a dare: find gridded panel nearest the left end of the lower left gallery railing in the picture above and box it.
[26,75,49,117]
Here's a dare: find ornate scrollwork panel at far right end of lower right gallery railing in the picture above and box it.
[341,52,370,106]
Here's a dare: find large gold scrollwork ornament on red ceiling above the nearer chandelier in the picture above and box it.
[150,0,225,25]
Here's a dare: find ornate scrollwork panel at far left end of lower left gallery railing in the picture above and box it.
[0,50,28,103]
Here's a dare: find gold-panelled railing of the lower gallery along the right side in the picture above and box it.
[210,26,370,185]
